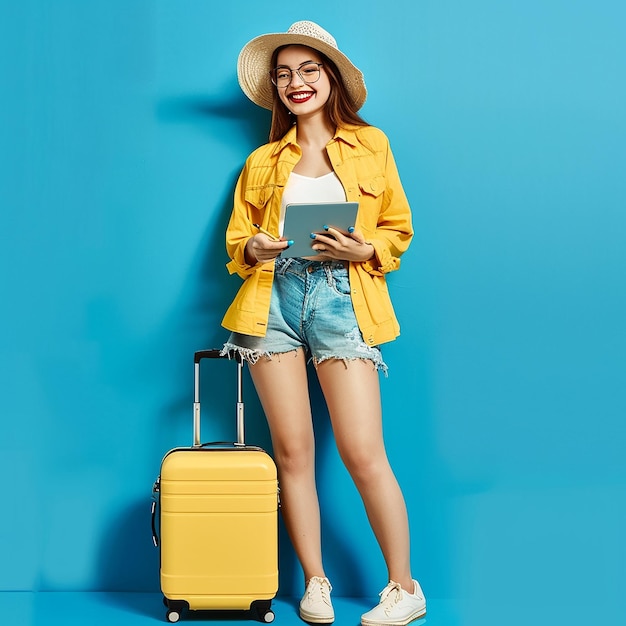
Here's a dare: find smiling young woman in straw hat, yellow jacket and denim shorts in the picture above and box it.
[223,21,426,626]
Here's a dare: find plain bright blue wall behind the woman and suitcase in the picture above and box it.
[0,0,626,624]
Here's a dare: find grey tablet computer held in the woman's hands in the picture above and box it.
[280,202,359,259]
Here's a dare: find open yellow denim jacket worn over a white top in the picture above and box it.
[222,126,413,345]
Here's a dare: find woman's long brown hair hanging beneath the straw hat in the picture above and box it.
[270,46,368,141]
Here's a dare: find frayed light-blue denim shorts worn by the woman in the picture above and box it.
[222,258,387,373]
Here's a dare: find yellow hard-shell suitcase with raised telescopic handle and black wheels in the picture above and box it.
[152,350,278,623]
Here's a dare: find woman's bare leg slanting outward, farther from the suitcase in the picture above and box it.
[317,359,413,593]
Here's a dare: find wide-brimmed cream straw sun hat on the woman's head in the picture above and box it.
[237,21,367,110]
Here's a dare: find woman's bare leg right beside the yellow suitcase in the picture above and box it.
[250,350,325,581]
